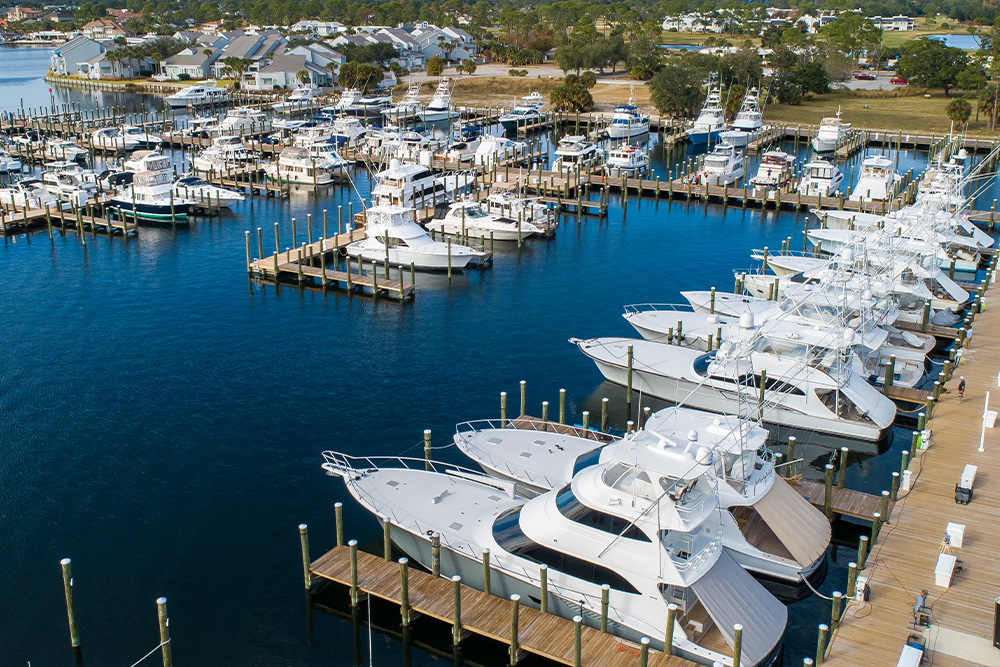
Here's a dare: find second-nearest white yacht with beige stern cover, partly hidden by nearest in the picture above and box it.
[454,407,831,599]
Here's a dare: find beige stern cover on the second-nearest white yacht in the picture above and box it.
[753,475,830,567]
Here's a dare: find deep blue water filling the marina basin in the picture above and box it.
[0,49,995,665]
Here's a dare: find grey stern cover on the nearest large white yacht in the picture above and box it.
[691,549,788,666]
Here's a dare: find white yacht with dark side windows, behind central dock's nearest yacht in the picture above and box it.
[371,158,476,208]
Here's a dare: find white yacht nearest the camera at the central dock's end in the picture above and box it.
[347,206,484,271]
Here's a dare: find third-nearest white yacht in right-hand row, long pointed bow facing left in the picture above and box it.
[571,332,896,441]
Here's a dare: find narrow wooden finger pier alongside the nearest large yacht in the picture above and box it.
[309,547,694,667]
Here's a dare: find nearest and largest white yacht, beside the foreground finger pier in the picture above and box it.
[323,446,787,667]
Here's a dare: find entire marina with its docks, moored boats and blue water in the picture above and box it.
[0,40,1000,667]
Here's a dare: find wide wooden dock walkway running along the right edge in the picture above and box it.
[820,264,1000,667]
